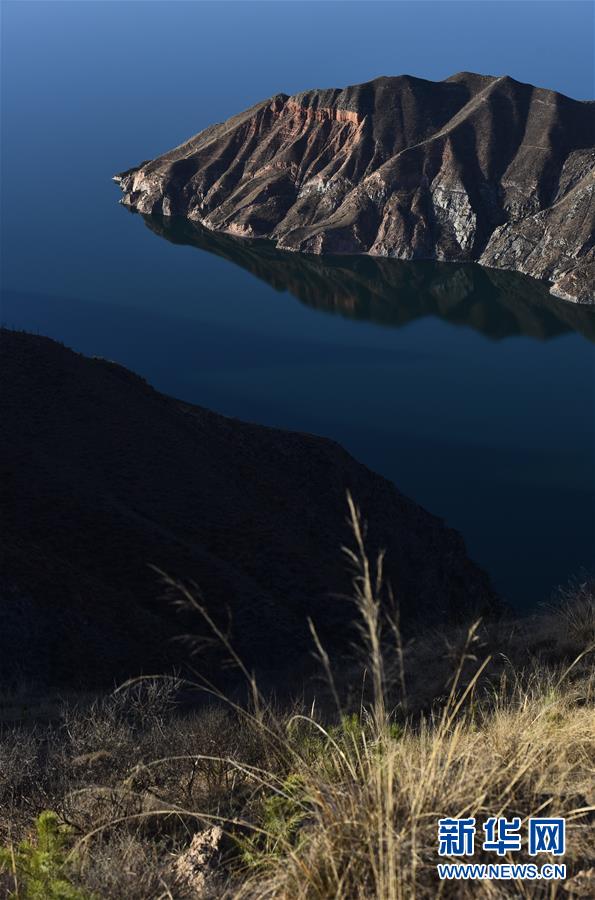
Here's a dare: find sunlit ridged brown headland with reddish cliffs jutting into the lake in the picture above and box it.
[115,72,595,303]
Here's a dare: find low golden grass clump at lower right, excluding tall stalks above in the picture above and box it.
[234,672,595,898]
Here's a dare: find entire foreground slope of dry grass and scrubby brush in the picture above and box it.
[0,505,595,900]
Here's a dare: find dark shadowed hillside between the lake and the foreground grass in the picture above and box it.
[0,329,499,683]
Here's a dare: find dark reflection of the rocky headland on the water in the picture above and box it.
[142,216,595,341]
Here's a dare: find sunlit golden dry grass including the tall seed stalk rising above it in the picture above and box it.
[225,505,595,900]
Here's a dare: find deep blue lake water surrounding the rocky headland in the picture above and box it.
[1,3,595,607]
